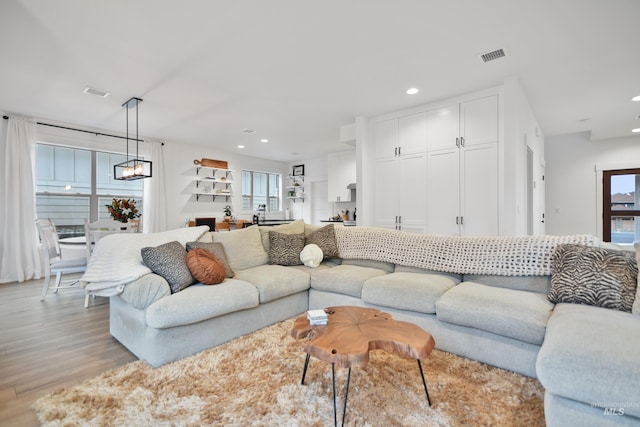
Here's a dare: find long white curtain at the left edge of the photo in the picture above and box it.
[0,116,42,282]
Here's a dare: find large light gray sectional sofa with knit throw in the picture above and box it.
[83,221,640,426]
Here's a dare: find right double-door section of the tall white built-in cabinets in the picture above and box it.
[427,95,499,235]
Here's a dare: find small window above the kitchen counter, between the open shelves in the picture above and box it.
[242,170,280,212]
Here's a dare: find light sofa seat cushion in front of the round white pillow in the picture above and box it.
[235,265,309,304]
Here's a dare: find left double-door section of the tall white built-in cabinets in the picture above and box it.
[373,112,427,233]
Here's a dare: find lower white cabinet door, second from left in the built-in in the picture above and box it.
[397,152,427,233]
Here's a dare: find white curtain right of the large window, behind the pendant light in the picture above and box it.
[142,141,167,233]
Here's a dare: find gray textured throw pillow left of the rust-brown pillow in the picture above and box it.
[140,240,195,293]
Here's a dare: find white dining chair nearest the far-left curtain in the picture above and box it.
[36,219,87,301]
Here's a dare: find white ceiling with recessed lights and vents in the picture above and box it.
[0,0,640,161]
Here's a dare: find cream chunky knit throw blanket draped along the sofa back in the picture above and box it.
[335,227,599,276]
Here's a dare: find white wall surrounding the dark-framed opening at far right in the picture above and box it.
[545,132,640,237]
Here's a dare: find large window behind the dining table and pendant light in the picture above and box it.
[36,144,142,237]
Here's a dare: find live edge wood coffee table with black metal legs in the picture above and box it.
[291,306,436,425]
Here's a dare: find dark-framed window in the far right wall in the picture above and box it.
[602,169,640,243]
